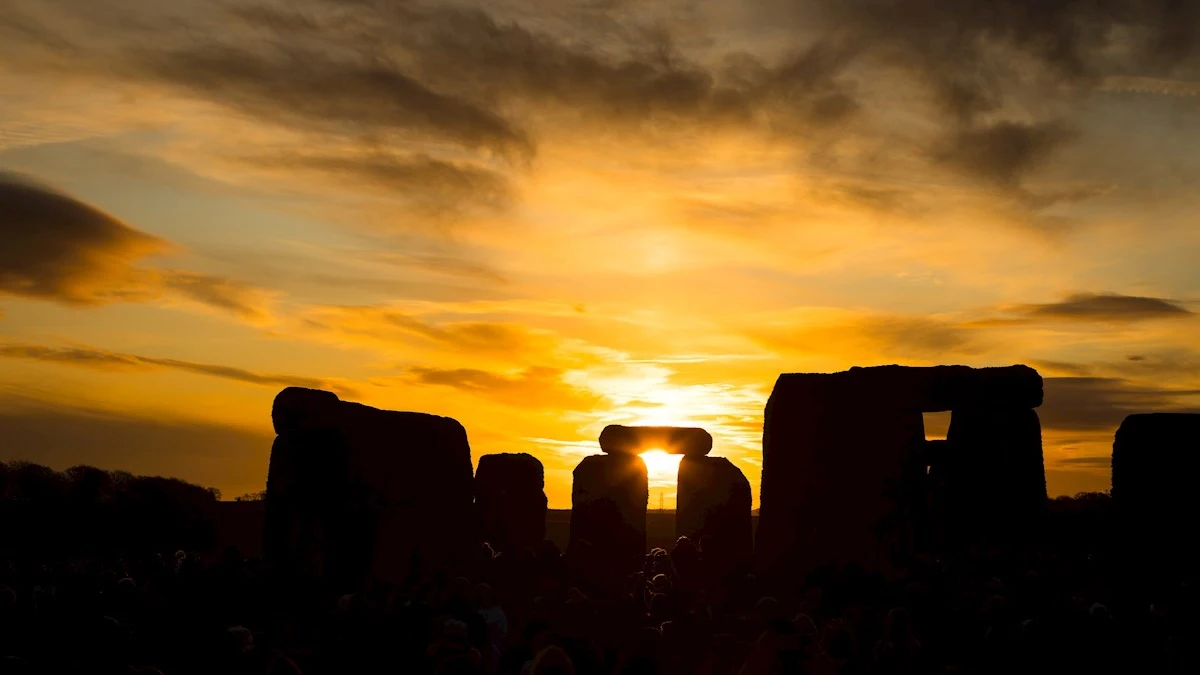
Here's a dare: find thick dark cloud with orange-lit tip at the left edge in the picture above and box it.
[0,172,168,305]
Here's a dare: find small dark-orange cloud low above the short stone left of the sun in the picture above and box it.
[408,368,606,412]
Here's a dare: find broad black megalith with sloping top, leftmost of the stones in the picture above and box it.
[264,387,476,590]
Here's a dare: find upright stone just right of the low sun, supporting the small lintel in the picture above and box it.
[676,456,754,554]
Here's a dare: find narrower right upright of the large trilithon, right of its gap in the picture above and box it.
[942,407,1048,548]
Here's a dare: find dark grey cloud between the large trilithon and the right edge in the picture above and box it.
[1038,377,1200,431]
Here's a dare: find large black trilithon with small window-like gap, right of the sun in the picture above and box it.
[755,365,1045,574]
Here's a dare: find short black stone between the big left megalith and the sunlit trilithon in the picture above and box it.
[475,453,546,552]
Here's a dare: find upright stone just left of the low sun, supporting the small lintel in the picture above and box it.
[568,455,650,574]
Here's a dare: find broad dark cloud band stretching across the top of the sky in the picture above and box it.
[10,0,1200,210]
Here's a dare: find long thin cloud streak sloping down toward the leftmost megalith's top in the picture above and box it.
[0,342,356,398]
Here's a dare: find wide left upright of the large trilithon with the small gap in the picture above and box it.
[755,369,925,575]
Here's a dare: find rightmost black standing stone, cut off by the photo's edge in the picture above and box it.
[1112,413,1200,574]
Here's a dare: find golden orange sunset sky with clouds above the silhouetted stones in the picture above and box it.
[0,0,1200,508]
